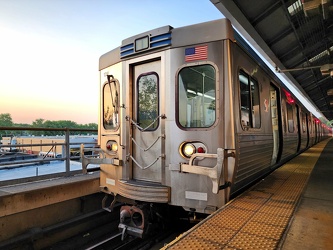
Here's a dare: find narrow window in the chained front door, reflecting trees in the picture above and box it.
[137,73,159,131]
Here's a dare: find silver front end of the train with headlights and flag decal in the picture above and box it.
[81,19,235,237]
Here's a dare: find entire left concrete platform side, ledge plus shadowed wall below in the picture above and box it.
[0,172,103,246]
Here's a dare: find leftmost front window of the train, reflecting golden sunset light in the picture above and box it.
[103,79,119,130]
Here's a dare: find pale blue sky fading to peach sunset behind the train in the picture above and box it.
[0,0,223,124]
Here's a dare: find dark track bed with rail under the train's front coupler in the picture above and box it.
[47,204,194,250]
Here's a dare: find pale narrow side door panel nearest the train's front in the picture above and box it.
[270,84,282,165]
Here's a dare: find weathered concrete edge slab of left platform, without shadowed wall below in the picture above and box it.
[0,172,100,218]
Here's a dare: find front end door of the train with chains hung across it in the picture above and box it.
[131,60,163,183]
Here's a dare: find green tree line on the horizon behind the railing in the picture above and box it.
[0,113,98,137]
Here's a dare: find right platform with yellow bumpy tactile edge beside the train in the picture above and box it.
[163,139,333,250]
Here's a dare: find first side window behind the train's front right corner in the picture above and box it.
[239,70,261,130]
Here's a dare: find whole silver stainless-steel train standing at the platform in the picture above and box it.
[81,19,332,237]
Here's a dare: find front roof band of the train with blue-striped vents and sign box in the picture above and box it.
[99,18,234,70]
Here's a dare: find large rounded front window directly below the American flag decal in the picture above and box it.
[178,64,216,128]
